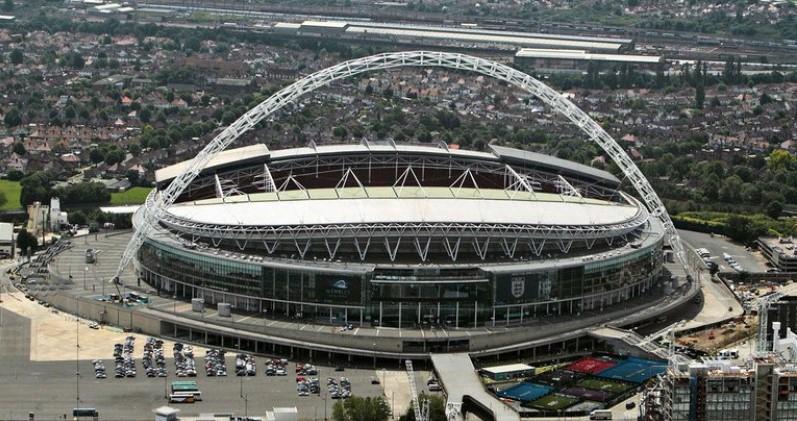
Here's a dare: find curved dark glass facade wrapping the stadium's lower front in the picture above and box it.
[139,236,662,328]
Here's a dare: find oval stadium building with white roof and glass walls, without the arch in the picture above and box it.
[134,142,665,329]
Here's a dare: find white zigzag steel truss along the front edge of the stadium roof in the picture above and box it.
[145,189,650,262]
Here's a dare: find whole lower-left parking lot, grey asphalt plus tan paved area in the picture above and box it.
[0,270,436,420]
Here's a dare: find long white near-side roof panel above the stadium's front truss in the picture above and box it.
[168,187,640,226]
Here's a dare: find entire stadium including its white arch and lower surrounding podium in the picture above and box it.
[114,51,696,361]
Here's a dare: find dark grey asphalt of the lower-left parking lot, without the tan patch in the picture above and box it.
[0,306,410,420]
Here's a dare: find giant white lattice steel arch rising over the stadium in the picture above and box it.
[114,51,687,282]
